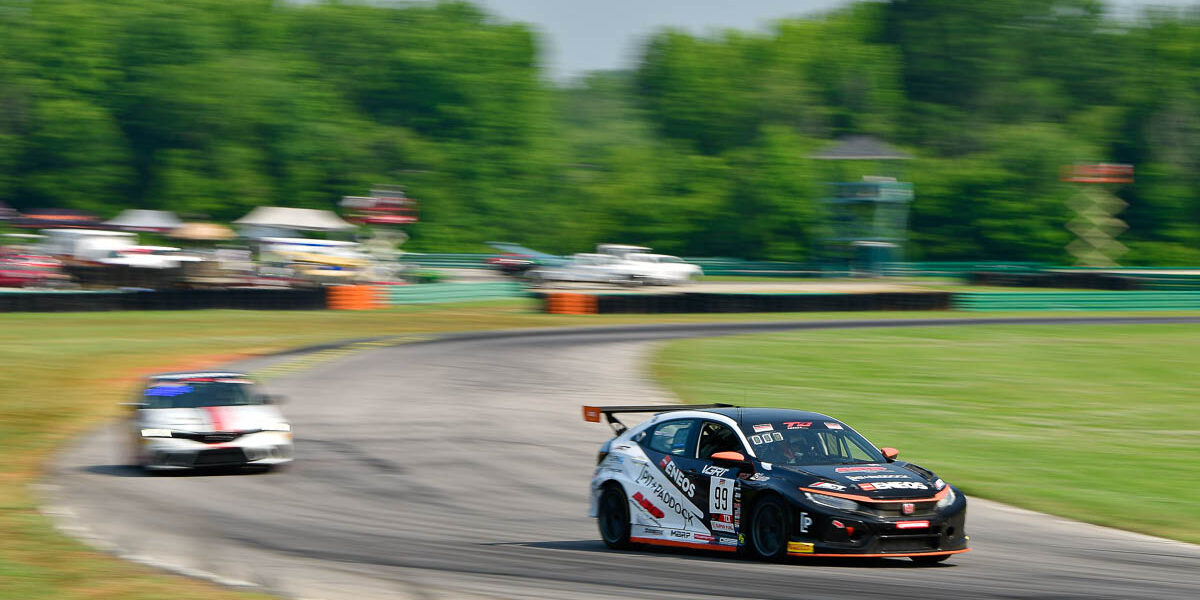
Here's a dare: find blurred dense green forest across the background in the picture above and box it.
[0,0,1200,265]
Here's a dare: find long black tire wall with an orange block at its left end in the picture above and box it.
[538,292,952,314]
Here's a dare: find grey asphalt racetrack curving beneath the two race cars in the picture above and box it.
[44,318,1200,600]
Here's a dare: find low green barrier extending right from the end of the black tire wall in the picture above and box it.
[952,290,1200,311]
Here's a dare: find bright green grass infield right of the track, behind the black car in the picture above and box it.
[655,325,1200,542]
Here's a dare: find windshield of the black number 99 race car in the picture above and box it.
[745,421,884,466]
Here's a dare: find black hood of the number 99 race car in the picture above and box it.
[775,463,946,499]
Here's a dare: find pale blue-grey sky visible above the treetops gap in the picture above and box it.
[476,0,1200,80]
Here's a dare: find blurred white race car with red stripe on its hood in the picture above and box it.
[130,372,292,469]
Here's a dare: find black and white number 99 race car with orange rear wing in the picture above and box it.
[583,404,968,563]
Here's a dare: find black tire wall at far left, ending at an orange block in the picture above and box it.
[0,289,325,312]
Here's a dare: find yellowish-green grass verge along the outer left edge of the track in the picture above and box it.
[0,301,1194,600]
